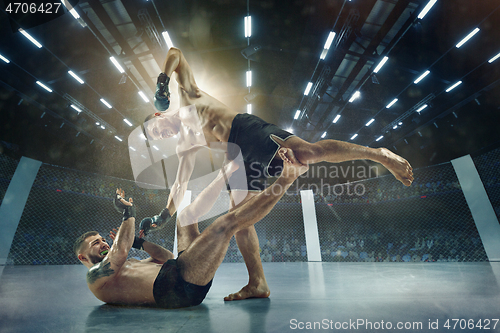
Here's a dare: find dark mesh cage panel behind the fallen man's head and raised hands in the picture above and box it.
[7,164,174,265]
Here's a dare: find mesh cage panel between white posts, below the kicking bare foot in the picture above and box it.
[316,163,487,262]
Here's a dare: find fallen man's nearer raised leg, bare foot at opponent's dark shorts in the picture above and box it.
[178,148,308,286]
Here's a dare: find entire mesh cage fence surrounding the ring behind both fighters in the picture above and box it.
[0,151,499,265]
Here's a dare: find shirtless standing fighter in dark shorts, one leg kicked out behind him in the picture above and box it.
[140,48,413,301]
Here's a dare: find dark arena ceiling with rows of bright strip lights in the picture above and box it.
[0,0,500,179]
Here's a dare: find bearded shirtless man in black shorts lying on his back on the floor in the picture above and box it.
[74,148,308,308]
